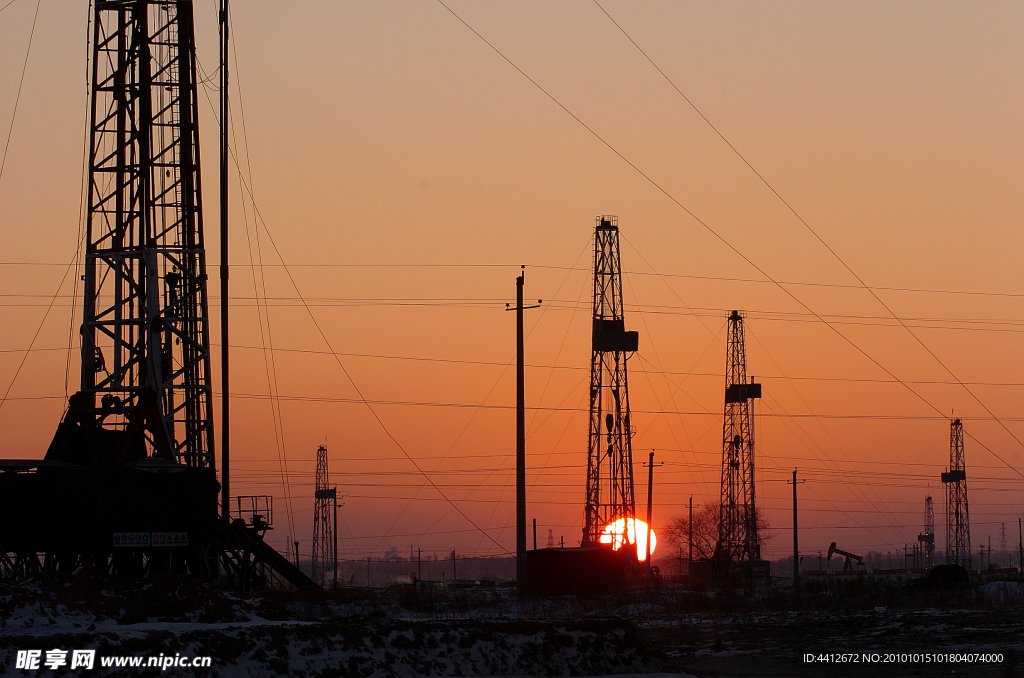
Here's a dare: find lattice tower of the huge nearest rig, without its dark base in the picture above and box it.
[47,0,214,467]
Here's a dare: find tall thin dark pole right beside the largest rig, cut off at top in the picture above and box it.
[220,0,231,521]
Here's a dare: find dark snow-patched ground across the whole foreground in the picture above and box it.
[0,574,1024,678]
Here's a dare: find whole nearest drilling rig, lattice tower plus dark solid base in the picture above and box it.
[0,0,218,577]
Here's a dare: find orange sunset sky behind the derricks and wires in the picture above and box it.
[0,0,1024,566]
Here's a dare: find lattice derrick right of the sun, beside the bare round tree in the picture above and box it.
[718,310,761,570]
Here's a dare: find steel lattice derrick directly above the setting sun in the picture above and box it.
[583,216,639,546]
